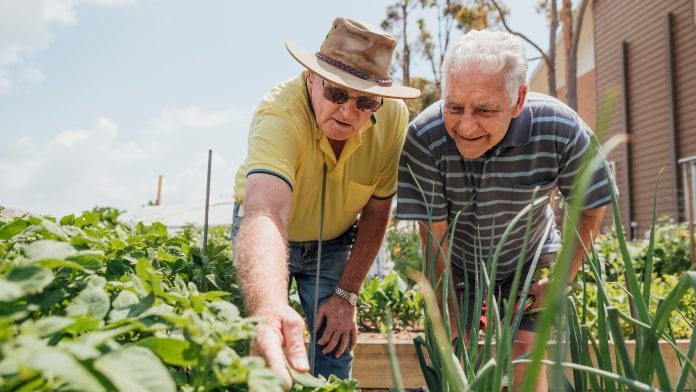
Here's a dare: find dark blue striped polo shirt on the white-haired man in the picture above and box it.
[396,93,611,281]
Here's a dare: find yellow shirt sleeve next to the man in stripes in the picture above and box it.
[373,100,408,199]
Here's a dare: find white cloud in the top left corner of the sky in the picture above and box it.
[0,0,136,93]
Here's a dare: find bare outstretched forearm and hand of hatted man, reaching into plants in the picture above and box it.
[235,173,309,388]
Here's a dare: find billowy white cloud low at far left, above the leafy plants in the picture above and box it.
[0,117,150,215]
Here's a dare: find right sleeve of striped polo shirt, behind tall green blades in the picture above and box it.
[558,117,618,210]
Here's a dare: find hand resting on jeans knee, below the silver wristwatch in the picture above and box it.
[315,295,358,358]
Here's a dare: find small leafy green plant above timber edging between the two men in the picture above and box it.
[358,273,423,331]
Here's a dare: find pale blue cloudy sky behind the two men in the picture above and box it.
[0,0,546,216]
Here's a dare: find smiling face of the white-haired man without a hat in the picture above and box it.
[443,67,527,158]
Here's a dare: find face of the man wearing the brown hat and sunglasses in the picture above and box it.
[307,72,379,140]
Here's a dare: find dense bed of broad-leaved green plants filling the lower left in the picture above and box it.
[0,208,352,391]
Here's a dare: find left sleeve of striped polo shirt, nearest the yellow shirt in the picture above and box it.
[396,123,448,221]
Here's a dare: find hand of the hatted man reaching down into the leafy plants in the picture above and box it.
[251,305,309,389]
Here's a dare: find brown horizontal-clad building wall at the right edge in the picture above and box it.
[593,0,696,235]
